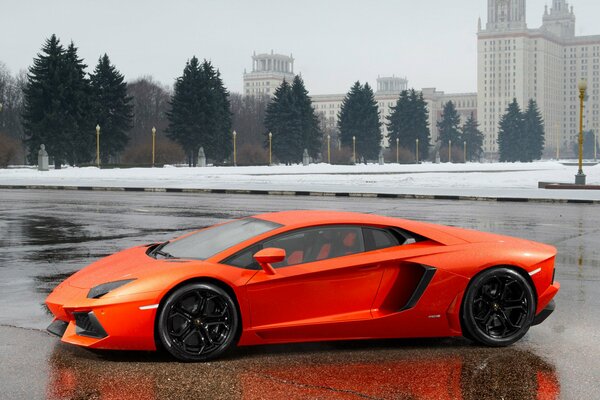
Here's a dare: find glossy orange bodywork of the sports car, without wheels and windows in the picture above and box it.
[46,211,559,350]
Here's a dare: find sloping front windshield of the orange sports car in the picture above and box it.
[160,218,281,260]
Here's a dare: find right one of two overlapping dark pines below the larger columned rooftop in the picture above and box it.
[292,75,323,158]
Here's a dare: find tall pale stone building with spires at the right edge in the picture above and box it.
[477,0,600,156]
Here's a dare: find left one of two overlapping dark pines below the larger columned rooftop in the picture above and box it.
[265,80,304,164]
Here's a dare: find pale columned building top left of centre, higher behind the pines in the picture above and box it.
[244,50,294,96]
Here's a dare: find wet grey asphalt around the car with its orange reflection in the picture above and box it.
[0,190,600,399]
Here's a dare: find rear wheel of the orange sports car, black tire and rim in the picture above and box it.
[462,267,536,347]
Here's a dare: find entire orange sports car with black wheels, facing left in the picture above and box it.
[46,211,560,361]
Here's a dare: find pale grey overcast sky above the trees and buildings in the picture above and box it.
[0,0,600,94]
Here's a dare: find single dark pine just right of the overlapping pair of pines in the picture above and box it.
[338,81,382,161]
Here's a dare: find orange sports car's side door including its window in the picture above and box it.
[246,225,383,329]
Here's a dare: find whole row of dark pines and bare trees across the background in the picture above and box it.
[0,35,568,168]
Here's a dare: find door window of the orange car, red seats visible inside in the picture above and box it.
[263,226,365,268]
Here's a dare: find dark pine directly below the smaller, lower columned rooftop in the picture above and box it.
[387,89,430,160]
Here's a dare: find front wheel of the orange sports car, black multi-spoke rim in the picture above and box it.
[157,283,240,361]
